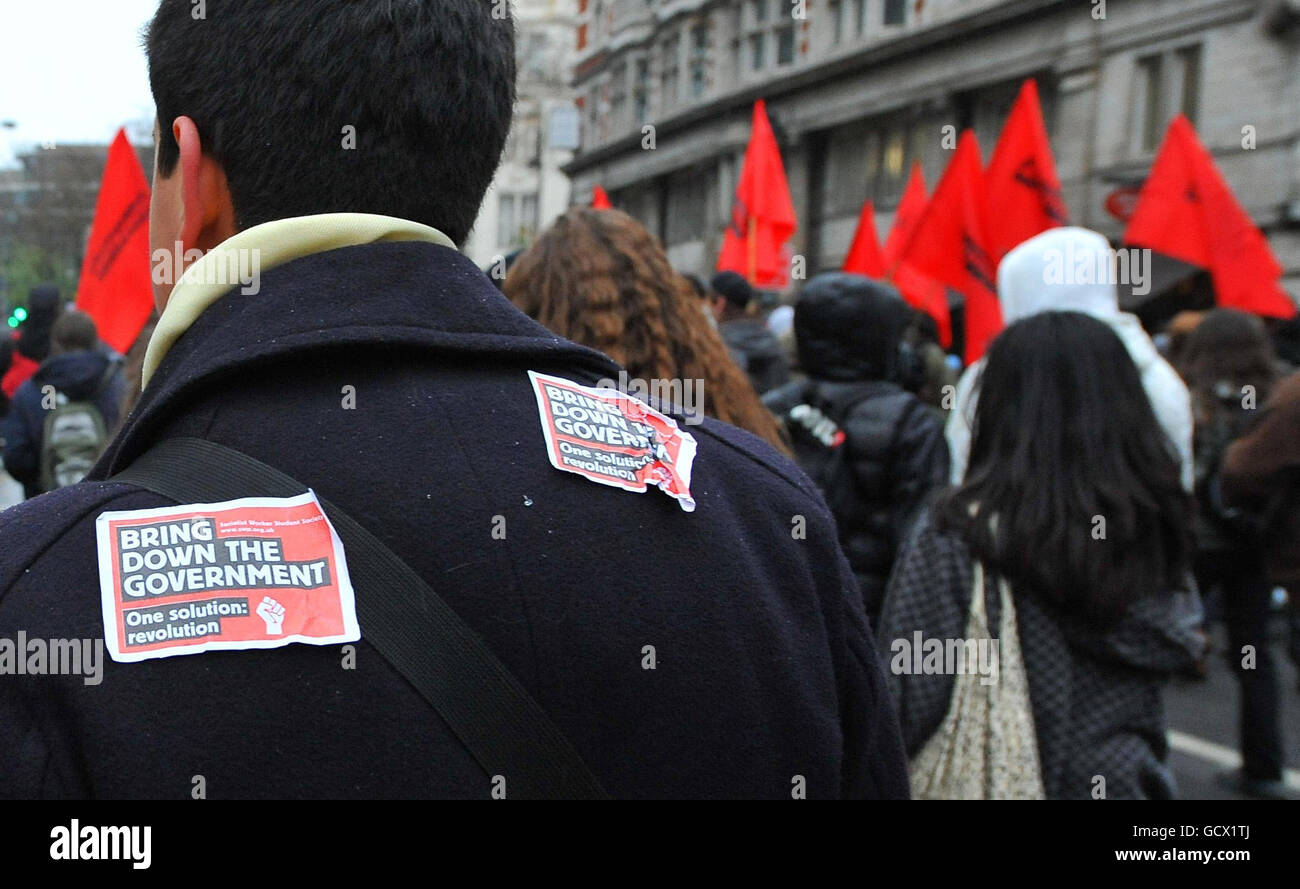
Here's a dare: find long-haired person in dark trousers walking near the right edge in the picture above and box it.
[1179,308,1294,798]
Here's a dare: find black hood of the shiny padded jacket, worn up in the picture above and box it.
[794,272,913,382]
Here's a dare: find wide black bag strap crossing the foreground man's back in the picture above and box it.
[109,438,607,799]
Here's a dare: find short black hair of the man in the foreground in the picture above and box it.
[144,0,515,244]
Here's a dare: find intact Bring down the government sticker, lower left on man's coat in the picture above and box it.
[95,491,361,663]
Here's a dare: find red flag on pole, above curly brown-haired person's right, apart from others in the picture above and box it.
[718,99,798,289]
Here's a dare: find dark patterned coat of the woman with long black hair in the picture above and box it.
[878,511,1201,799]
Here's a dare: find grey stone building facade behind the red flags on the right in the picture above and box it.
[566,0,1300,296]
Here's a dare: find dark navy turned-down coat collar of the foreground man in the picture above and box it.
[90,242,619,478]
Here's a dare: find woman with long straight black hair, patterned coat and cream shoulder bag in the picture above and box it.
[880,312,1200,798]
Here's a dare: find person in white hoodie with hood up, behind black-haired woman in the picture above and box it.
[945,227,1195,490]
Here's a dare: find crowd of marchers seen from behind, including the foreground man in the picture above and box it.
[0,0,1300,798]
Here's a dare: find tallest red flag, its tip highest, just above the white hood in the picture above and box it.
[984,78,1070,261]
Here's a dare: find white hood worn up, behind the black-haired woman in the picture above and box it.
[997,227,1119,325]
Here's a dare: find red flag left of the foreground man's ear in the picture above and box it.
[77,130,153,352]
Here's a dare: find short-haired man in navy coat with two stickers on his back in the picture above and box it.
[0,0,907,798]
